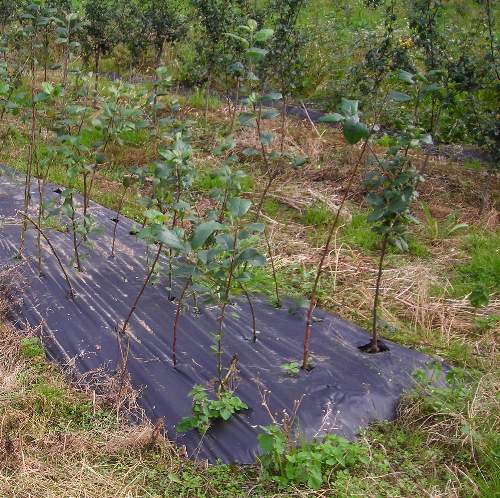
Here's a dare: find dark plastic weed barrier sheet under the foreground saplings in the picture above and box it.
[0,168,442,464]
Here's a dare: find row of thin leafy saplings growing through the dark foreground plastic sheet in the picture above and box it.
[0,4,432,486]
